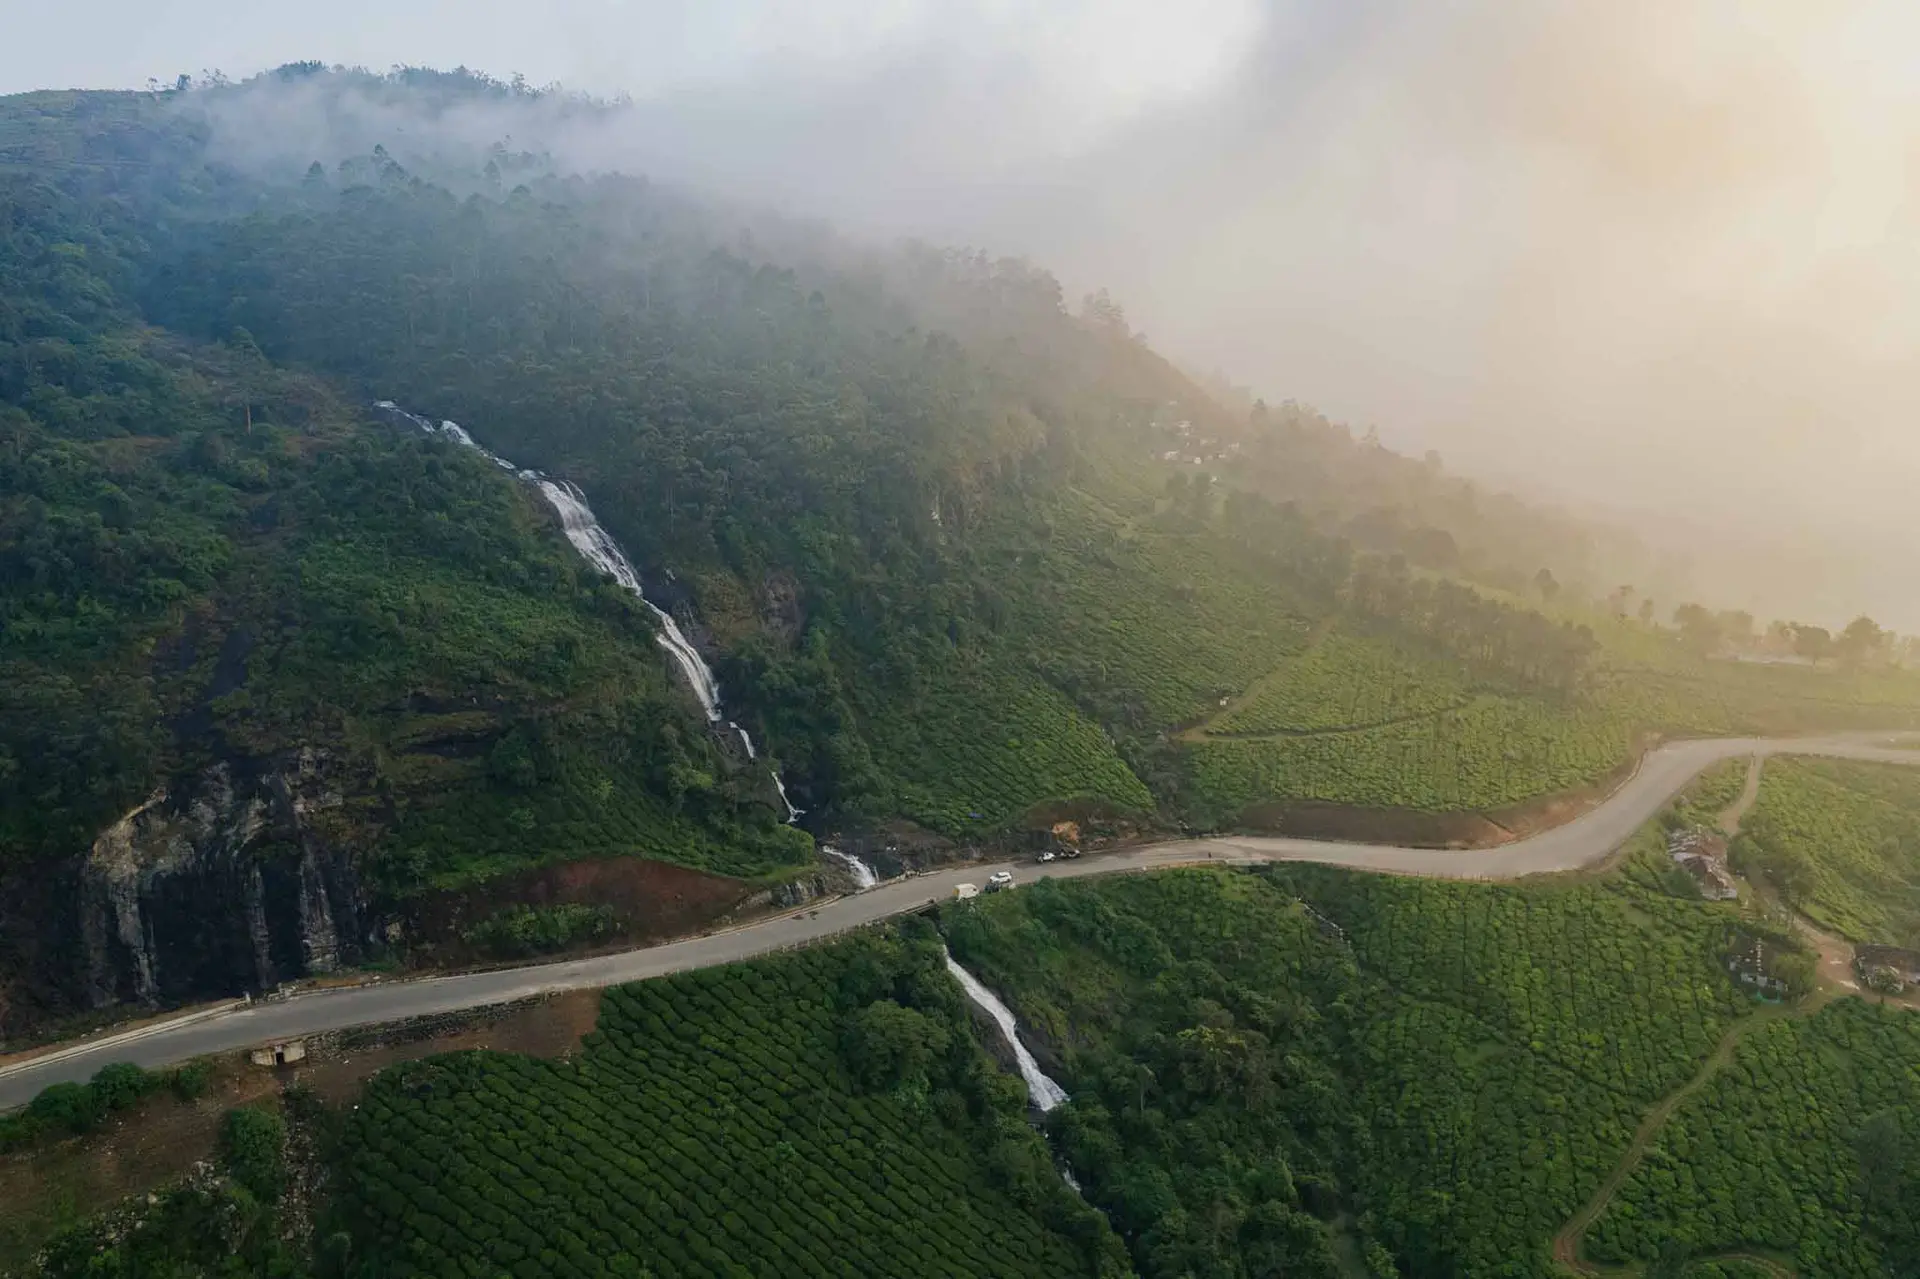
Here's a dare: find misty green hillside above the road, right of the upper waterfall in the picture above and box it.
[15,71,1920,860]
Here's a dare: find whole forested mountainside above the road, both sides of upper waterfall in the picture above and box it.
[0,65,1920,1033]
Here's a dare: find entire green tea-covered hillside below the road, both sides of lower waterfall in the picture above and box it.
[18,810,1920,1279]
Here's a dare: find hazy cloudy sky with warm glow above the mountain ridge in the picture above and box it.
[15,0,1920,628]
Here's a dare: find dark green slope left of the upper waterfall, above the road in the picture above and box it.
[0,162,806,1027]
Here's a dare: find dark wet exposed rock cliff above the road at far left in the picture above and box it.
[77,751,372,1008]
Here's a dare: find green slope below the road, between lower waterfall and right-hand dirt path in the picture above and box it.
[945,845,1766,1275]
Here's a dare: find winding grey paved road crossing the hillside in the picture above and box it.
[0,734,1920,1110]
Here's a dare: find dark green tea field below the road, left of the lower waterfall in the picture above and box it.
[320,926,1125,1279]
